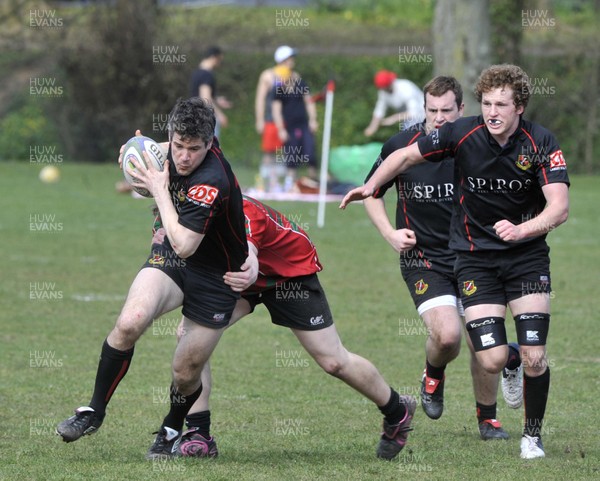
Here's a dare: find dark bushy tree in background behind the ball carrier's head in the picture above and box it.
[54,0,171,161]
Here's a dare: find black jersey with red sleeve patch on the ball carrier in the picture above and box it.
[166,137,248,273]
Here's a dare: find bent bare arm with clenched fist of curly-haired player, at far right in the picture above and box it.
[494,182,569,242]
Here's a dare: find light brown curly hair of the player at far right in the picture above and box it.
[475,64,531,108]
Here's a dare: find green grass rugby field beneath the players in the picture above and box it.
[0,163,600,481]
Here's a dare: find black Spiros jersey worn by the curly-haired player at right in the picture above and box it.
[417,115,569,251]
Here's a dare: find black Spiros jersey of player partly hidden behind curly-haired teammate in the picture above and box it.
[365,123,456,272]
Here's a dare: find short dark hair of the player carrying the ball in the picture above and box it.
[167,97,216,145]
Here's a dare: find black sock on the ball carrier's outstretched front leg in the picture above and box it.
[90,339,134,415]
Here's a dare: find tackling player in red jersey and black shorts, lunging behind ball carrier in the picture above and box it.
[147,196,416,460]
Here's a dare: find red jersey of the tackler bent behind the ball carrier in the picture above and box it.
[244,196,323,292]
